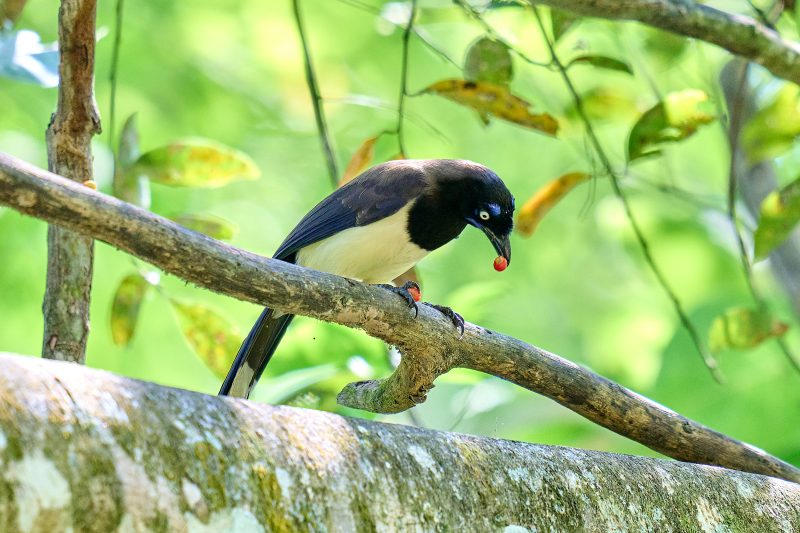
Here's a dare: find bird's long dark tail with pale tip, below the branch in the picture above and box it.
[219,308,294,398]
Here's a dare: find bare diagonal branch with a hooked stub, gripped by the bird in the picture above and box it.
[0,154,800,482]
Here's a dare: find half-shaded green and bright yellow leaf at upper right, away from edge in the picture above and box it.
[628,89,714,161]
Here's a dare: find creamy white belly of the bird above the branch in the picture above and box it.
[297,206,428,283]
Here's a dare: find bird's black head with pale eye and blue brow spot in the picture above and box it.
[462,171,514,268]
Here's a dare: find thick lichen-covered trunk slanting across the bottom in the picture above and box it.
[0,354,800,533]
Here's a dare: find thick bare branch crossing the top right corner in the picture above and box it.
[536,0,800,83]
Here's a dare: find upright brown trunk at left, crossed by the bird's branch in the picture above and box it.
[42,0,100,363]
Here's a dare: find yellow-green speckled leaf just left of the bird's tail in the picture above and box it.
[170,300,242,377]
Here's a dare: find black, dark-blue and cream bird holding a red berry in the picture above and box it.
[219,159,514,398]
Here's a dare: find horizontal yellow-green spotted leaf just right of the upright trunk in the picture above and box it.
[133,139,260,187]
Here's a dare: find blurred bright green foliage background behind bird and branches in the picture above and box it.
[0,0,800,465]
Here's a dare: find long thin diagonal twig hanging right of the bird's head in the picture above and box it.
[531,6,722,383]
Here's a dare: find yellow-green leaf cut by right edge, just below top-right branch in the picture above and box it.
[742,83,800,163]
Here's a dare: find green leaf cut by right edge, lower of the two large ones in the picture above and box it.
[754,178,800,259]
